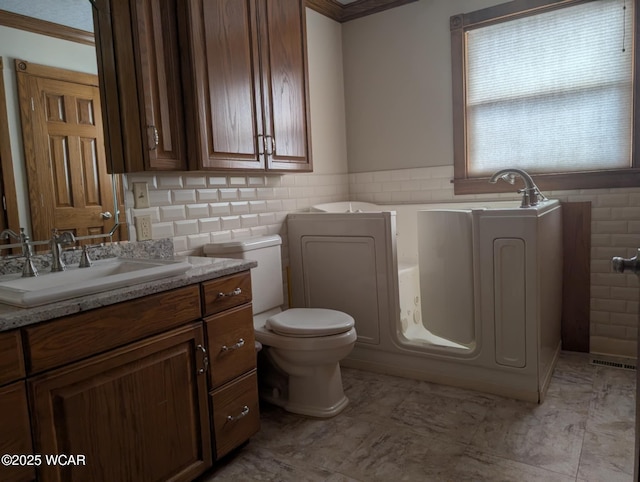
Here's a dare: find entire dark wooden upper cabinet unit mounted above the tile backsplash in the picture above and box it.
[94,0,312,172]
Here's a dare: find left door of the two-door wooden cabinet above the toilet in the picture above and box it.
[187,0,265,169]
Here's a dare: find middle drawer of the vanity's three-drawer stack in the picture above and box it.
[204,303,256,388]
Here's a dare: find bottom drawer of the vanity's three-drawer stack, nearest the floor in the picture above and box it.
[211,370,260,459]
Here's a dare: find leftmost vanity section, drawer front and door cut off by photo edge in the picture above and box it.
[0,330,36,482]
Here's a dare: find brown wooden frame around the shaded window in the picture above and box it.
[450,0,640,194]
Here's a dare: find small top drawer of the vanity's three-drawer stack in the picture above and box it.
[202,271,251,316]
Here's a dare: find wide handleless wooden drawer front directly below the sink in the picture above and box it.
[24,285,200,374]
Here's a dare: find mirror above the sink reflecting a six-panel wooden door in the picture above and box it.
[0,0,128,242]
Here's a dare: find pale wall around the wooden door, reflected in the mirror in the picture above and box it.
[0,25,98,232]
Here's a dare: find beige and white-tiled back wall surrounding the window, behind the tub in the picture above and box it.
[343,0,640,357]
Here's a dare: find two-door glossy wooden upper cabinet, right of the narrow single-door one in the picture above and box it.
[185,0,312,171]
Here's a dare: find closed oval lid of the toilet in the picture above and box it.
[264,308,355,337]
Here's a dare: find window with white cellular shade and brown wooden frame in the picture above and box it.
[451,0,640,194]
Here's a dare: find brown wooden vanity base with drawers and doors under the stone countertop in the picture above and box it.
[0,271,260,482]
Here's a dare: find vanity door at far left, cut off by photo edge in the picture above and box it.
[0,380,36,482]
